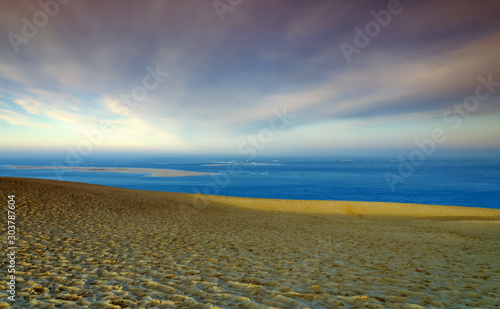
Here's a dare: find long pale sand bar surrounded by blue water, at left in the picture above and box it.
[8,166,216,177]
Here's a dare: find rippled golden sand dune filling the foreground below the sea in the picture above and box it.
[0,178,500,308]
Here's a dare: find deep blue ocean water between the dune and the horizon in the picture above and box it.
[0,158,500,209]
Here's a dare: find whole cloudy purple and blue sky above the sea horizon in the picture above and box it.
[0,0,500,157]
